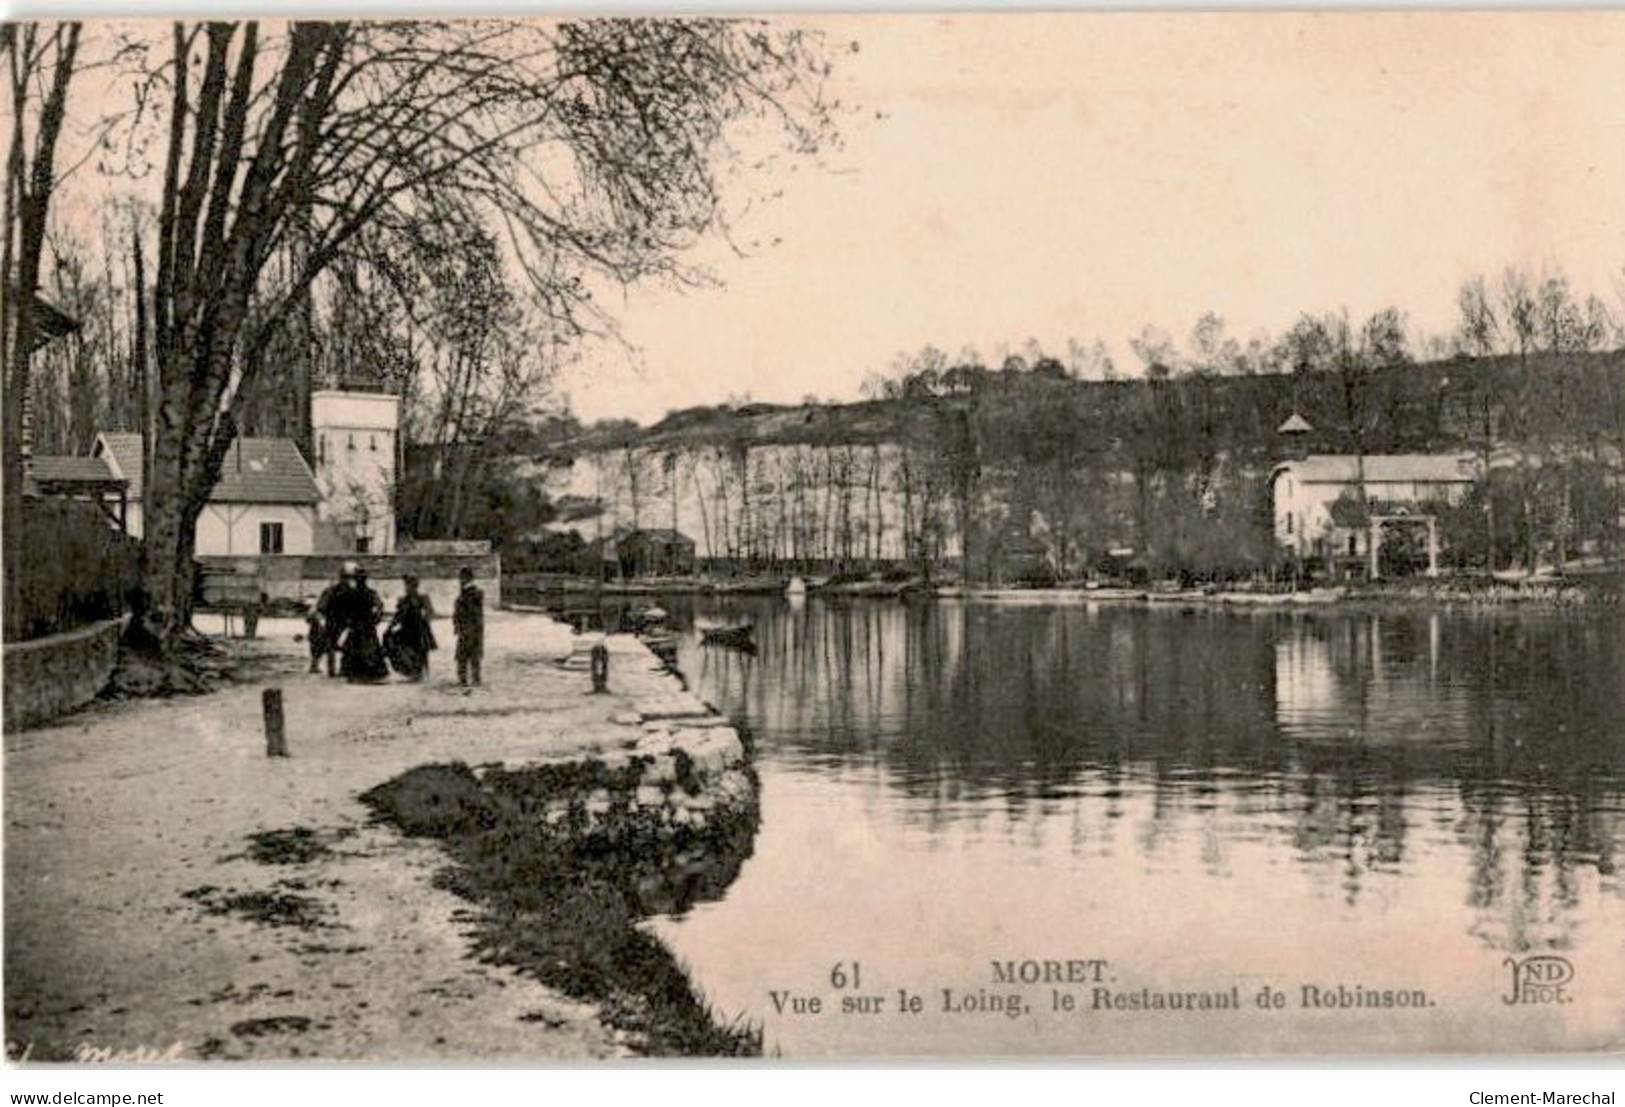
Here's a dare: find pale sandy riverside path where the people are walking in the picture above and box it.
[5,613,747,1061]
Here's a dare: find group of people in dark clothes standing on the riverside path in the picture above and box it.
[306,564,486,686]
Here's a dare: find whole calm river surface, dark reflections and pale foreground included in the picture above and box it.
[617,598,1625,1057]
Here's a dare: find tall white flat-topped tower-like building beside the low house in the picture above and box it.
[310,389,400,553]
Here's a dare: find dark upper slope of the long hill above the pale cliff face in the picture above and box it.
[554,351,1625,457]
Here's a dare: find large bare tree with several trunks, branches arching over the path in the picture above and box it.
[117,20,830,637]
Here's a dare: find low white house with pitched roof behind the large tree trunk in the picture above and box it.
[91,431,322,554]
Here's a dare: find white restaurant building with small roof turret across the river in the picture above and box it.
[1271,454,1477,559]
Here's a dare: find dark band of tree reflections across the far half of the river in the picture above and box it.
[676,601,1625,948]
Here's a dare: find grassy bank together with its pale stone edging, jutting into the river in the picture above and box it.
[362,630,762,1057]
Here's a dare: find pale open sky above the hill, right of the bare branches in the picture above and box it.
[561,11,1625,421]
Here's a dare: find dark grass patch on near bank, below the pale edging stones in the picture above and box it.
[362,761,762,1057]
